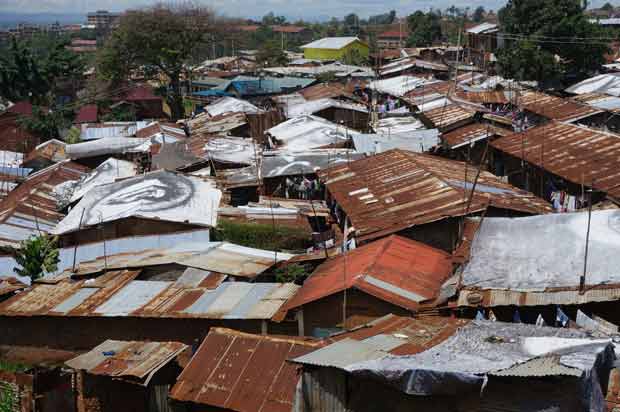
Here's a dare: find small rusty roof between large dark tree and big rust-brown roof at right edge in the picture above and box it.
[518,91,603,122]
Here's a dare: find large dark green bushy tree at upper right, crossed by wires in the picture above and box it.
[498,0,608,81]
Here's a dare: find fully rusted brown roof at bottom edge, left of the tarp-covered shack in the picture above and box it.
[170,328,321,412]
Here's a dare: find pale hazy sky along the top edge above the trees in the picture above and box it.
[0,0,620,19]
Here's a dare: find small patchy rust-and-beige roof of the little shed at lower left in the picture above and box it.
[65,340,187,386]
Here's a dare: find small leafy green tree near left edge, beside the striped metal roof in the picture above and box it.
[13,234,59,280]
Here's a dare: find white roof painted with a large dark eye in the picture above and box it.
[52,170,222,235]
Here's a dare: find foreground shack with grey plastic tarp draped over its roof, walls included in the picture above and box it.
[291,318,615,412]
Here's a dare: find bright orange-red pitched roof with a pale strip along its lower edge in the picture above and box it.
[285,235,452,310]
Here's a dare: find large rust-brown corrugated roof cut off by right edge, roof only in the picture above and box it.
[491,122,620,200]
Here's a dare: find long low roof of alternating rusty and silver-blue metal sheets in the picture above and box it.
[0,271,299,319]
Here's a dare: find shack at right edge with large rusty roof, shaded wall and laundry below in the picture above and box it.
[489,121,620,211]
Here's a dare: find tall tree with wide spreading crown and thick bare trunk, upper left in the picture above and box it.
[98,4,215,119]
